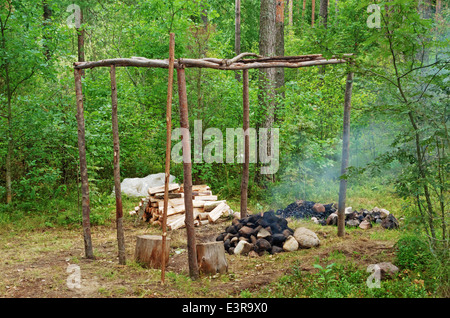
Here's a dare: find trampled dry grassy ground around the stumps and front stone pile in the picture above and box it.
[0,211,398,298]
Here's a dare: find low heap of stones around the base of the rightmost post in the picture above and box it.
[326,207,399,230]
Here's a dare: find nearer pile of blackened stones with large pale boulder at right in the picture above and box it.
[216,211,320,256]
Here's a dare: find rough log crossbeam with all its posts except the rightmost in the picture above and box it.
[74,33,352,283]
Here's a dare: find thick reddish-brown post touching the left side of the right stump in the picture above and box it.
[177,66,199,280]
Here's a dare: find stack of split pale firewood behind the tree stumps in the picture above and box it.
[130,183,233,230]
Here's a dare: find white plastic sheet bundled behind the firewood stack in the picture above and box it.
[119,173,175,197]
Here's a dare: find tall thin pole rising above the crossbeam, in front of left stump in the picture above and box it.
[161,33,175,284]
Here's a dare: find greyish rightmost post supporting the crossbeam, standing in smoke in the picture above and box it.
[338,72,353,236]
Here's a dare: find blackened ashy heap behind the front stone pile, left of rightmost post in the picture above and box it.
[276,200,337,225]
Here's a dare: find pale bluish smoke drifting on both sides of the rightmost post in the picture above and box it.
[269,118,398,209]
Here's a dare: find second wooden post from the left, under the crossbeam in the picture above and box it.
[109,65,126,265]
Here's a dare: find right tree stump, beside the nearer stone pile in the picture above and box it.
[197,242,228,275]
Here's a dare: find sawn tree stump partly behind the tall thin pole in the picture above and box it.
[134,235,170,268]
